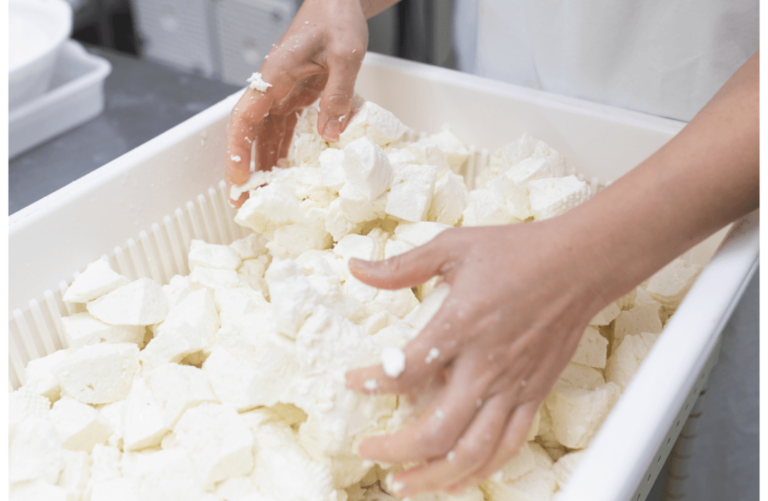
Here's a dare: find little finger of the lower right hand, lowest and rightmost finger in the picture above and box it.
[447,402,539,493]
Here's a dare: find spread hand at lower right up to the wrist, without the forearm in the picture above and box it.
[347,221,610,497]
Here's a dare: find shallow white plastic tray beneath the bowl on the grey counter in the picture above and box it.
[8,40,112,158]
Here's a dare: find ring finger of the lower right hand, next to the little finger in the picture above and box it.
[394,394,513,497]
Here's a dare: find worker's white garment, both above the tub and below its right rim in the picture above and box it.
[454,4,759,501]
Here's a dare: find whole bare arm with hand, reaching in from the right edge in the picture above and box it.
[347,54,759,496]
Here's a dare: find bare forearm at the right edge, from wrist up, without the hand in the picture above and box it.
[564,53,759,301]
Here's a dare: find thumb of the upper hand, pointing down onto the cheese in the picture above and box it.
[317,45,365,142]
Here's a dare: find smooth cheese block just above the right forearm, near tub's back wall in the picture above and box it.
[528,176,590,219]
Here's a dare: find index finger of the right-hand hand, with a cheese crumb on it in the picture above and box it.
[346,290,480,394]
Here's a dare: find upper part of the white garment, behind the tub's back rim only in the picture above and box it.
[454,0,759,121]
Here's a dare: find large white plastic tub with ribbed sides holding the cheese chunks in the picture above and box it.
[9,54,758,501]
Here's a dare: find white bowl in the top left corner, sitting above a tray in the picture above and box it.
[8,0,72,109]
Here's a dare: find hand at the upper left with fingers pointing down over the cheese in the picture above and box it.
[226,0,369,207]
